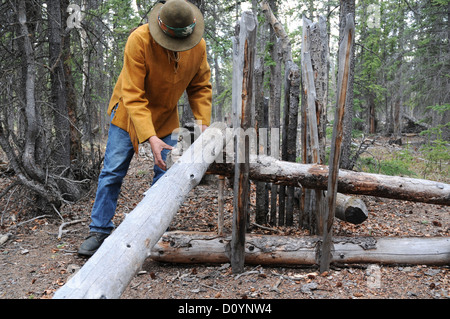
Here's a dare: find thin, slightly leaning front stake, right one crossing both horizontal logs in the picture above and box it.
[320,13,355,272]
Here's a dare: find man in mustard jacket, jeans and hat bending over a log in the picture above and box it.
[78,0,212,256]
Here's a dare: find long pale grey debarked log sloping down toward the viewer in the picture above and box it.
[54,124,231,299]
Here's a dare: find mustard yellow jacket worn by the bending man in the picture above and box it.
[108,24,212,152]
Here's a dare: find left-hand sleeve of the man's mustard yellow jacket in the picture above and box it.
[121,32,156,143]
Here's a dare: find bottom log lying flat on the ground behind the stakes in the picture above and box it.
[151,231,450,266]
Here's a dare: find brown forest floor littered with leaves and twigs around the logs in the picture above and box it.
[0,135,450,301]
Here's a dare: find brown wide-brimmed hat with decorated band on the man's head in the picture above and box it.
[148,0,205,52]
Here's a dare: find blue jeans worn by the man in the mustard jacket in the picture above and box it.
[89,112,177,234]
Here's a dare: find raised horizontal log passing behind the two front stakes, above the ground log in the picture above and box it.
[208,155,450,206]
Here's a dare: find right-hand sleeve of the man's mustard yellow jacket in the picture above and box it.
[186,40,212,126]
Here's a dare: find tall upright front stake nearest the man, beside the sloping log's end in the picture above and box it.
[231,11,258,273]
